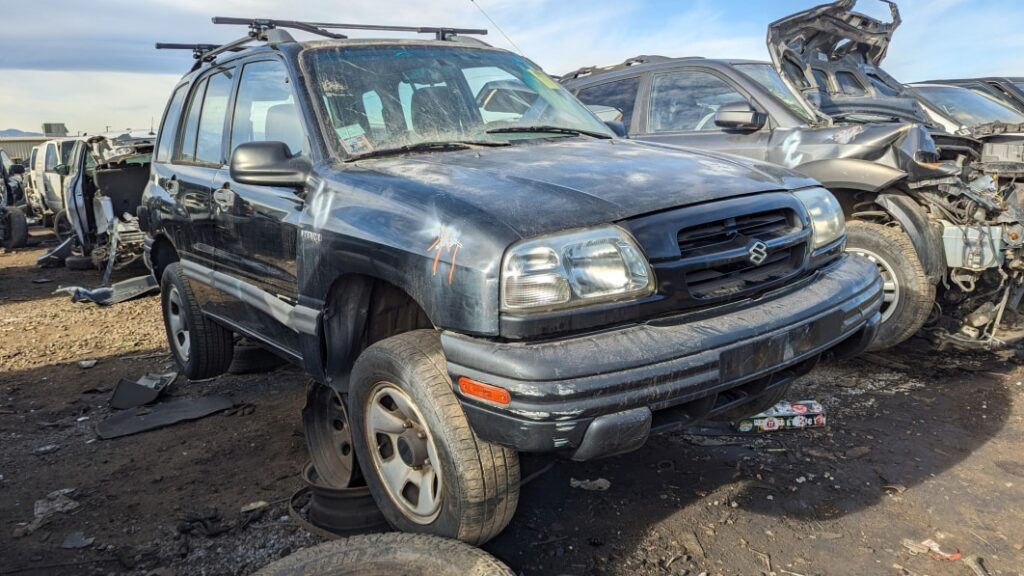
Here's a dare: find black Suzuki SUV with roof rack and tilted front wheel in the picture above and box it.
[139,19,882,543]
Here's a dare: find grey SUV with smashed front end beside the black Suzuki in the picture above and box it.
[563,1,1024,348]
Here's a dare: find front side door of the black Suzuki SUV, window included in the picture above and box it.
[213,56,309,351]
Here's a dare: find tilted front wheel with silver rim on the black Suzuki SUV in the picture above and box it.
[348,330,519,544]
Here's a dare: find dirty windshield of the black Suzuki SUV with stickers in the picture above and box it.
[306,46,611,157]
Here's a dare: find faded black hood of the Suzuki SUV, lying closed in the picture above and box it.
[356,139,817,238]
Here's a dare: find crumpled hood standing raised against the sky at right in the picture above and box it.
[768,0,927,122]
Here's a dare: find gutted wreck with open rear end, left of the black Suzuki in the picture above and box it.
[60,132,155,284]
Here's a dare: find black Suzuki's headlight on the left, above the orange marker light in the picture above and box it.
[502,225,654,312]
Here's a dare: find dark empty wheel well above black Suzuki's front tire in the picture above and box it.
[318,274,434,394]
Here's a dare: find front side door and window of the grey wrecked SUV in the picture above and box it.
[634,68,771,160]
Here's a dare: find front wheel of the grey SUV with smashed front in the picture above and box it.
[846,220,935,351]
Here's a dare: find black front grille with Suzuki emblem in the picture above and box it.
[677,208,808,300]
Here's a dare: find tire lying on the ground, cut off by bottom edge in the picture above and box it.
[256,532,515,576]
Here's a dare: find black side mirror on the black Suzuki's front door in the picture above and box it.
[230,141,312,188]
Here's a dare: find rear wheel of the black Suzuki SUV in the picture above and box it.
[160,262,234,380]
